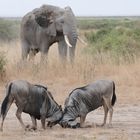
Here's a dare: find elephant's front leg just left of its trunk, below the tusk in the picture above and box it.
[58,40,67,63]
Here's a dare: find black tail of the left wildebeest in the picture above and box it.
[1,83,12,116]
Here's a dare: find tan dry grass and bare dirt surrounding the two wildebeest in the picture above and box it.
[0,43,140,140]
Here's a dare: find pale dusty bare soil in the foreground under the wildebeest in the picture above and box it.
[0,83,140,140]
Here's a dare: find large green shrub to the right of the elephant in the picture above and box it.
[84,19,140,63]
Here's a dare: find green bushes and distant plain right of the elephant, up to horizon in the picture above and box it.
[78,18,140,64]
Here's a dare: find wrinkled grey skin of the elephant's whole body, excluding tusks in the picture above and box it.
[21,5,77,62]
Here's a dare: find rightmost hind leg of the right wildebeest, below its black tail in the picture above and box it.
[103,97,113,126]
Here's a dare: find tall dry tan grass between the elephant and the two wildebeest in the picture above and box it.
[0,42,140,103]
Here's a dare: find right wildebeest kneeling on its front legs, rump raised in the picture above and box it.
[60,80,116,128]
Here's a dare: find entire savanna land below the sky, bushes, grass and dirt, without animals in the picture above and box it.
[0,17,140,140]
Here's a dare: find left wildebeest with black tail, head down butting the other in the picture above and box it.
[0,80,63,131]
